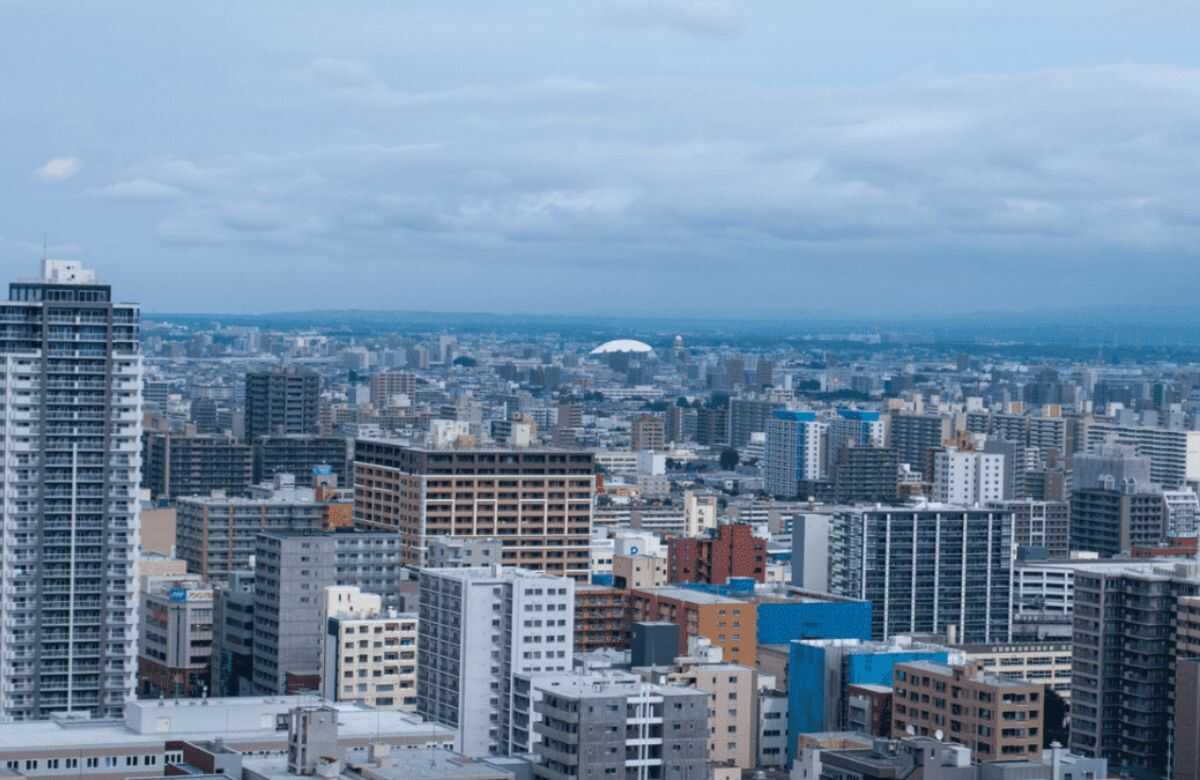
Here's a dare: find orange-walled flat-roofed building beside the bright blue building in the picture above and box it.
[629,587,758,668]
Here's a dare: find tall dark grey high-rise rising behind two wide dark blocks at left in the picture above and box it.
[246,366,320,442]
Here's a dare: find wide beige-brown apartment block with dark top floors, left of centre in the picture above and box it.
[354,439,595,573]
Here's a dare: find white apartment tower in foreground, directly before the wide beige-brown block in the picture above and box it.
[416,565,575,757]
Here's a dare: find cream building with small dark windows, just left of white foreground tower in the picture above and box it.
[320,586,418,712]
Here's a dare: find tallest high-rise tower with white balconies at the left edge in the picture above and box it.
[0,259,143,720]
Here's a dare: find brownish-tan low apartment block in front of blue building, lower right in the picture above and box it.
[892,661,1045,763]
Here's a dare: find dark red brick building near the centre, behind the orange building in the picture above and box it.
[667,523,767,584]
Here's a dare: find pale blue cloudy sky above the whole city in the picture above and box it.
[0,0,1200,319]
